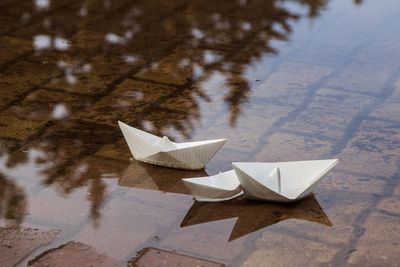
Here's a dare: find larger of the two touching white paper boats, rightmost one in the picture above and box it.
[232,159,338,202]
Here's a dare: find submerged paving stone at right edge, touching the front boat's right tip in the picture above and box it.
[337,120,400,177]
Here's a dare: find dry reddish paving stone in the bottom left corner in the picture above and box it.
[0,227,58,267]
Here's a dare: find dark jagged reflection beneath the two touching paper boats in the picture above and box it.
[181,196,332,241]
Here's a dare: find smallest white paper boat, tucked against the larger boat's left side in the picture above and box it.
[182,170,243,202]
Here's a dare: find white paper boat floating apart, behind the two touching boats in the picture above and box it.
[118,121,226,170]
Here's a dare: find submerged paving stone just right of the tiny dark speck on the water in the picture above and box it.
[251,62,332,106]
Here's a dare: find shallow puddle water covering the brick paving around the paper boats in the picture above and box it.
[0,0,400,266]
